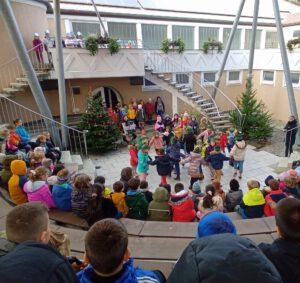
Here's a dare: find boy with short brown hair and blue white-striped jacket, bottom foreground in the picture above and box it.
[77,219,165,283]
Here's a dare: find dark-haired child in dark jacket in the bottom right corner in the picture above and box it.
[259,198,300,283]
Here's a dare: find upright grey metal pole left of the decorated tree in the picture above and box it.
[53,0,68,147]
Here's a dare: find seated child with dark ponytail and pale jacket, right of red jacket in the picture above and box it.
[197,185,224,219]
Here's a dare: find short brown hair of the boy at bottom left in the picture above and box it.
[6,202,49,244]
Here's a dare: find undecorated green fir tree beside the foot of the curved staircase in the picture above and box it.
[230,79,273,141]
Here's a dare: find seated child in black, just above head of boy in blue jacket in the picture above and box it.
[87,183,121,226]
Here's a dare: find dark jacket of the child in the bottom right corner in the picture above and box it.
[258,238,300,283]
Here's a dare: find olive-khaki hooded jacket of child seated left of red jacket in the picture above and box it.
[148,188,172,221]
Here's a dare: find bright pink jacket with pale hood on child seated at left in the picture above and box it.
[23,181,55,208]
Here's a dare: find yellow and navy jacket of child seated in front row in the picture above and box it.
[240,188,265,218]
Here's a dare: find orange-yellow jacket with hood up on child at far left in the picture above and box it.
[8,160,28,204]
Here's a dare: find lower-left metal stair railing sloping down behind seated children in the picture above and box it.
[0,94,87,155]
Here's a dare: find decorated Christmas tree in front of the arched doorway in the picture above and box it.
[79,96,121,152]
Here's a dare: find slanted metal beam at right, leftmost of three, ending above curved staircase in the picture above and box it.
[213,0,245,97]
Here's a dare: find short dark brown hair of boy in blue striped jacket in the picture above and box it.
[85,219,128,274]
